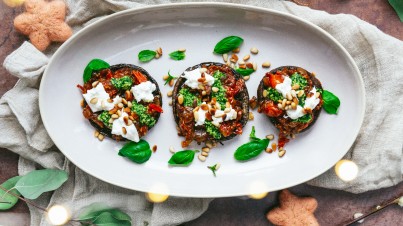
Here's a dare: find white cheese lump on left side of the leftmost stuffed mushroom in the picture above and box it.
[83,83,116,112]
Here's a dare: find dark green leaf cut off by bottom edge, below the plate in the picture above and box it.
[78,203,132,226]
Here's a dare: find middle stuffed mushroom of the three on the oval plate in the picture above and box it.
[172,62,249,147]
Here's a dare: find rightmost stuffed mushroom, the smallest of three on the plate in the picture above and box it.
[257,66,323,148]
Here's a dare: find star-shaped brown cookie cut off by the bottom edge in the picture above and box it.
[266,190,319,226]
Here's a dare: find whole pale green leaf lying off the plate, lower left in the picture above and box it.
[14,169,68,199]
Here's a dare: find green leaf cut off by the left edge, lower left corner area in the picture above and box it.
[0,176,21,210]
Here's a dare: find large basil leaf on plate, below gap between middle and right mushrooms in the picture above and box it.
[234,139,270,161]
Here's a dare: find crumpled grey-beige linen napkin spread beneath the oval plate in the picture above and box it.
[0,0,403,225]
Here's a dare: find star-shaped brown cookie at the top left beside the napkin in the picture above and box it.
[14,0,72,51]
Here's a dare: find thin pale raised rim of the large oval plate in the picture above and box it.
[39,2,366,198]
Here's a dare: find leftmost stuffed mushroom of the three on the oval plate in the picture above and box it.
[78,64,162,142]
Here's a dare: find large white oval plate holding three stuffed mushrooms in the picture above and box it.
[39,3,365,197]
